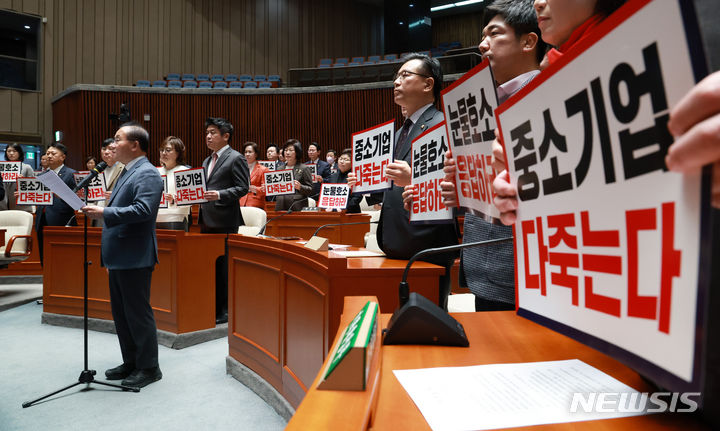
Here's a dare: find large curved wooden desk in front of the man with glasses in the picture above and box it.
[228,235,444,407]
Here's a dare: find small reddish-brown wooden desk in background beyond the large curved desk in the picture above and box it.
[265,211,370,247]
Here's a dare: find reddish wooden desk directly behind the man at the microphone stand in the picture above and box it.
[43,230,225,334]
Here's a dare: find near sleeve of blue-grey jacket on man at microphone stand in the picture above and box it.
[103,167,163,227]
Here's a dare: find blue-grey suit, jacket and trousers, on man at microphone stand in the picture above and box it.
[101,157,163,369]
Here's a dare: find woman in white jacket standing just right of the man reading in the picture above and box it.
[156,136,190,232]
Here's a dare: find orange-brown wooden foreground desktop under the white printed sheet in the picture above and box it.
[285,297,709,431]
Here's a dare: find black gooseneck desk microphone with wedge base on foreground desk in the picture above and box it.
[383,237,513,347]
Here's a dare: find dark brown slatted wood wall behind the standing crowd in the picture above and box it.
[53,86,408,169]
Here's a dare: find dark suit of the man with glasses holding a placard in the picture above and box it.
[377,106,458,307]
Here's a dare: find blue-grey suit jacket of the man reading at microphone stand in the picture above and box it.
[101,157,163,269]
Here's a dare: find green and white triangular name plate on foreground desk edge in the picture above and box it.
[318,301,379,391]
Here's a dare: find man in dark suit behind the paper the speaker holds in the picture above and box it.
[35,142,77,265]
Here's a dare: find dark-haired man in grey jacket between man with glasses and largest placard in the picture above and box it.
[403,0,546,311]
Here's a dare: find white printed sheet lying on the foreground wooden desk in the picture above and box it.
[393,359,652,431]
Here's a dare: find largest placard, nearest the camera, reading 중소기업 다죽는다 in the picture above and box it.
[496,0,710,390]
